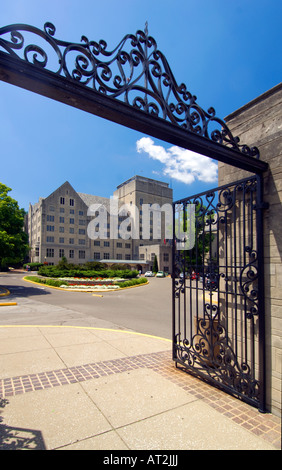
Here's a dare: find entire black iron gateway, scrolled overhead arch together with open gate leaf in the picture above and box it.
[0,23,268,411]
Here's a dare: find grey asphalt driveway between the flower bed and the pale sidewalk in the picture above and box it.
[0,273,172,339]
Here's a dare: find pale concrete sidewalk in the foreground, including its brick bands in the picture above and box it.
[0,324,281,451]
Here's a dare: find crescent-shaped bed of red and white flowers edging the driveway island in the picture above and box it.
[24,276,148,292]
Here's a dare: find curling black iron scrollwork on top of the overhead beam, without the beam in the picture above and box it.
[0,22,259,158]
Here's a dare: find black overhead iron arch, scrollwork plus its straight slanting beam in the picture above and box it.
[0,22,267,173]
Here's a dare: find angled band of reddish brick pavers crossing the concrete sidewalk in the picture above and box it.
[0,351,281,449]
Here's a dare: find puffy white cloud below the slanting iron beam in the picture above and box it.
[136,137,218,184]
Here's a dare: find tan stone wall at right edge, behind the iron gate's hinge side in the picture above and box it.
[219,83,282,416]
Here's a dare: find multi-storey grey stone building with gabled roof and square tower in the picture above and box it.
[27,176,172,272]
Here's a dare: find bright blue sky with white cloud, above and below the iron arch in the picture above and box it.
[0,0,282,210]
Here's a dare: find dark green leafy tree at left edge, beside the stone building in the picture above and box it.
[0,183,29,270]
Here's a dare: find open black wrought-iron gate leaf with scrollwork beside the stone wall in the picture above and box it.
[173,176,265,411]
